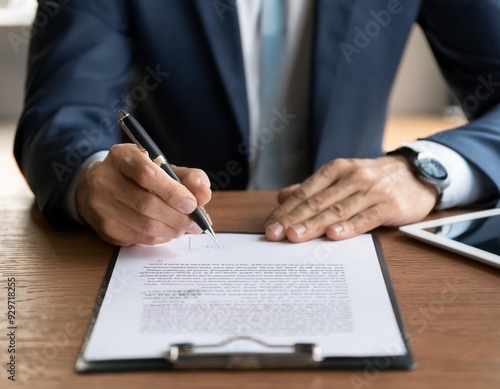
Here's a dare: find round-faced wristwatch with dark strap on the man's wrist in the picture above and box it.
[386,147,450,205]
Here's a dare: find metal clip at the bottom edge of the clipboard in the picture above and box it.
[165,336,323,370]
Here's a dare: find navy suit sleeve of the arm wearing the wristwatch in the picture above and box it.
[419,0,500,200]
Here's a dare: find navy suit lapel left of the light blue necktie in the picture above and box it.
[194,0,249,140]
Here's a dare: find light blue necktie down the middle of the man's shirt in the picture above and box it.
[249,0,309,189]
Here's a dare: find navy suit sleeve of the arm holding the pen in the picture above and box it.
[14,0,131,228]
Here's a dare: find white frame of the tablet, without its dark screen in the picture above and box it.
[399,208,500,269]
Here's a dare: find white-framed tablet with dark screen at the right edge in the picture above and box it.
[399,208,500,269]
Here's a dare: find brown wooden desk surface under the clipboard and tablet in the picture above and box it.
[0,119,500,389]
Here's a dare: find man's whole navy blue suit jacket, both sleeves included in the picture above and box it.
[14,0,500,226]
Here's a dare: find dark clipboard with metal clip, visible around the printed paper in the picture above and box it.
[75,235,417,373]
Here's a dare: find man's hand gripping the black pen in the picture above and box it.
[75,144,212,246]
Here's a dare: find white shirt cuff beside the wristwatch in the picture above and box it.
[404,140,487,210]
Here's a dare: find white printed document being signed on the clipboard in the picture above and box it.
[77,234,412,370]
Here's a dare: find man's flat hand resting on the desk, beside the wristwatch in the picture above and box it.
[264,156,437,242]
